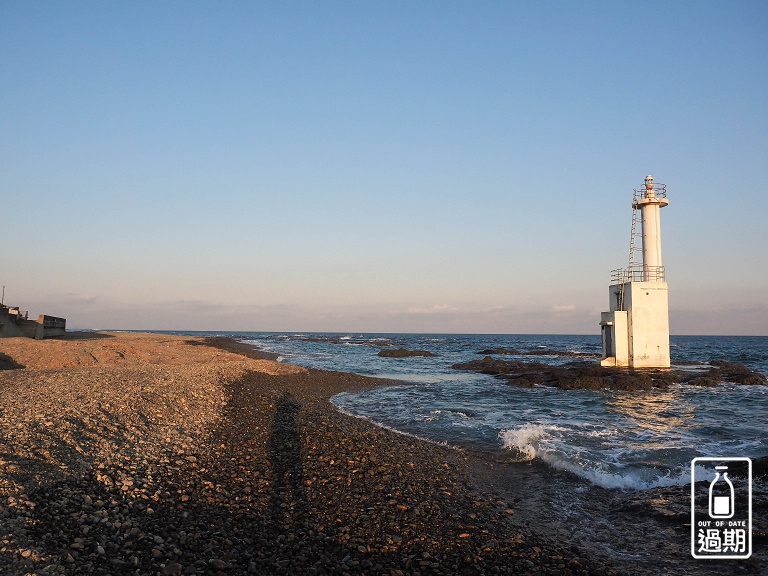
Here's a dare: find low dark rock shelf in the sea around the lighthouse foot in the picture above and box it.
[453,356,768,390]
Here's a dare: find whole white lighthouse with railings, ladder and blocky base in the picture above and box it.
[600,175,669,368]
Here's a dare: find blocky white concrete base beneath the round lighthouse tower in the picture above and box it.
[600,282,669,368]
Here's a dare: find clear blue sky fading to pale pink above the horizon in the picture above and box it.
[0,0,768,335]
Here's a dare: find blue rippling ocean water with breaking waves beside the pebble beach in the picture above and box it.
[178,332,768,489]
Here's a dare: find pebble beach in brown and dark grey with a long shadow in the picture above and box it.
[0,333,763,575]
